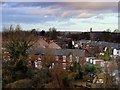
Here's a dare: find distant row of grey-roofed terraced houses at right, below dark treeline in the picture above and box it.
[75,40,120,58]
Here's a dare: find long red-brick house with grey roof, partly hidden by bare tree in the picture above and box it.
[29,48,85,69]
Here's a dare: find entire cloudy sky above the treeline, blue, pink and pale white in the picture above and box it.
[0,1,118,32]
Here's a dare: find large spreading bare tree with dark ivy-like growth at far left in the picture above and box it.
[2,24,35,85]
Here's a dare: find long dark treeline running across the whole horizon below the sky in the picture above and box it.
[3,25,120,43]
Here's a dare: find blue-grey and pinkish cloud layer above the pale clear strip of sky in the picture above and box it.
[2,2,116,23]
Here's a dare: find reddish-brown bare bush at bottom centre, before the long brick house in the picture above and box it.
[45,64,73,88]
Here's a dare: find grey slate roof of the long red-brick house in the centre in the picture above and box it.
[34,48,84,57]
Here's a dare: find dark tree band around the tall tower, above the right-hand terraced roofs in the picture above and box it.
[67,32,120,43]
